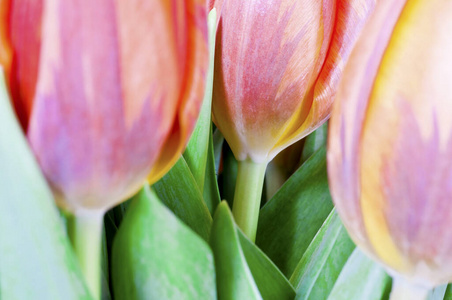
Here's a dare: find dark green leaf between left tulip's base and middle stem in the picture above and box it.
[153,157,212,241]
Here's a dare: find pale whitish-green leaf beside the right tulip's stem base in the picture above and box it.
[328,248,391,300]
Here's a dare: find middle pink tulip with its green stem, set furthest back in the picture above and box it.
[212,0,375,239]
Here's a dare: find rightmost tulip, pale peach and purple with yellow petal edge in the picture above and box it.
[328,0,452,299]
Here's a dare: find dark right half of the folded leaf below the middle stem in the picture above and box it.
[236,231,295,300]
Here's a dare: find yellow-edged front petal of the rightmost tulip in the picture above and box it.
[361,0,452,284]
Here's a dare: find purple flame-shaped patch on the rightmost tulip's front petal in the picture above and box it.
[379,102,452,285]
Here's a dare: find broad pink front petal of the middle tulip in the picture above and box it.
[213,0,335,162]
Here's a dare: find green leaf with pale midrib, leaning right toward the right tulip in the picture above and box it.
[290,211,355,299]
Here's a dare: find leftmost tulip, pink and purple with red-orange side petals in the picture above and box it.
[0,0,208,296]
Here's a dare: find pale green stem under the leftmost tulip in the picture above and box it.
[69,210,104,300]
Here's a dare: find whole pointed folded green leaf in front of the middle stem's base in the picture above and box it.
[210,201,295,300]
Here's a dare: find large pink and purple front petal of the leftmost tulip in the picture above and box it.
[29,0,202,210]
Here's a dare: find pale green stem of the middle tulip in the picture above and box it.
[232,160,267,242]
